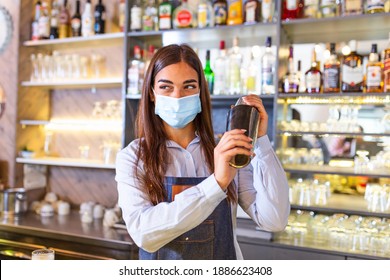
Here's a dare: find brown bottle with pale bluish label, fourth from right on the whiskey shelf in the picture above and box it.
[323,43,340,93]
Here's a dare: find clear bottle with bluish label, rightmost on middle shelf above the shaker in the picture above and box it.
[261,37,276,94]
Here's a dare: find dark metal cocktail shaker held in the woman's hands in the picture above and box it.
[226,98,260,168]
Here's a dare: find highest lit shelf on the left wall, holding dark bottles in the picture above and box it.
[23,32,124,47]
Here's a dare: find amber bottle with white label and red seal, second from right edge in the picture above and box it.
[366,44,383,92]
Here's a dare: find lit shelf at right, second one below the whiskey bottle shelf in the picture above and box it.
[283,164,390,178]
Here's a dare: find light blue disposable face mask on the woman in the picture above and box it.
[154,93,202,128]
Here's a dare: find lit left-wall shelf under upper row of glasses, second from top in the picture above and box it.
[22,77,123,88]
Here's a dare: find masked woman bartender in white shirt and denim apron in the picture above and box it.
[115,45,290,259]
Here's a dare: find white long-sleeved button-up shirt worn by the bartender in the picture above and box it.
[115,135,290,259]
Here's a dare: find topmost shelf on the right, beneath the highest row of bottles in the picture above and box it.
[282,13,390,44]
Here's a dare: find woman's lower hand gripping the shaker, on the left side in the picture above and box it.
[214,129,252,190]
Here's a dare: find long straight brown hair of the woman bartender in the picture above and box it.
[135,44,237,205]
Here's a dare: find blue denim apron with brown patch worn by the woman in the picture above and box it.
[139,177,237,260]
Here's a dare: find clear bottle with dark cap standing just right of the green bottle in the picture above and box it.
[214,40,228,95]
